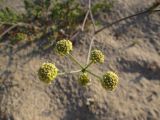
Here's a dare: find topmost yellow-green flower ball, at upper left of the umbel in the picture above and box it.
[56,39,73,56]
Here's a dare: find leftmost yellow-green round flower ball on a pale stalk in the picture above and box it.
[38,63,58,83]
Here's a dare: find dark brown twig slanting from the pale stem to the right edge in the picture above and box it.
[94,10,160,35]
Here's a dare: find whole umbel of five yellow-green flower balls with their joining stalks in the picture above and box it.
[38,39,119,91]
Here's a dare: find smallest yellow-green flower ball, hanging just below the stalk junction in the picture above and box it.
[78,73,90,86]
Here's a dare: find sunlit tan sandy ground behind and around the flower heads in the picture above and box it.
[0,0,160,120]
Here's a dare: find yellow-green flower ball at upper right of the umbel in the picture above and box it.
[90,49,104,63]
